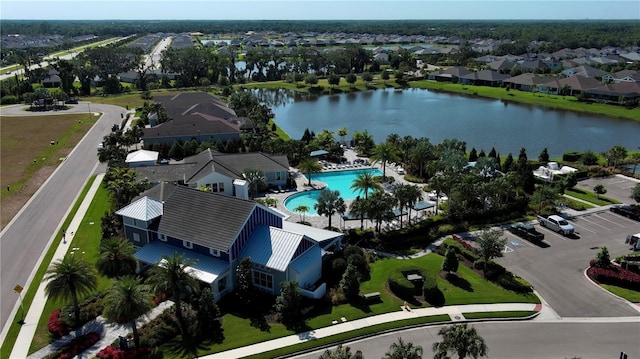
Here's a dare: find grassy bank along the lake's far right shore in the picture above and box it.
[409,80,640,121]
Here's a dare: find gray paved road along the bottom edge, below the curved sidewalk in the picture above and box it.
[295,321,640,359]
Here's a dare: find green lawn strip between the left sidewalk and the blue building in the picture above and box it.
[29,185,111,353]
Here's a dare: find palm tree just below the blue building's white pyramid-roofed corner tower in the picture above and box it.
[96,238,138,278]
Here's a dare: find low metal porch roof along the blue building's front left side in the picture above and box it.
[134,241,229,284]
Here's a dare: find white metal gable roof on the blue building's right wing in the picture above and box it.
[240,226,304,272]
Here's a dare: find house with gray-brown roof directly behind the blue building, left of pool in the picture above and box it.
[184,149,289,197]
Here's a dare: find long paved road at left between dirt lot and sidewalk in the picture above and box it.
[0,103,125,337]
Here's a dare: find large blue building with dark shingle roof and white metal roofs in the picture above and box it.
[116,186,342,300]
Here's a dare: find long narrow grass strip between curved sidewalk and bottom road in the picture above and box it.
[218,314,451,359]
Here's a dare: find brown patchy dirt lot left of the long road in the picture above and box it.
[0,114,95,228]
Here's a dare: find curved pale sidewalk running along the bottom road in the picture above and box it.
[201,303,542,359]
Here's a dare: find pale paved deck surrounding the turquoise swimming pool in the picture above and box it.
[256,149,430,230]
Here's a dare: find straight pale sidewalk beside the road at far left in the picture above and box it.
[10,174,104,358]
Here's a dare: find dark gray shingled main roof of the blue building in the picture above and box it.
[158,186,257,252]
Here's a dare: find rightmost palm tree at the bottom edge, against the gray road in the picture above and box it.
[433,323,489,359]
